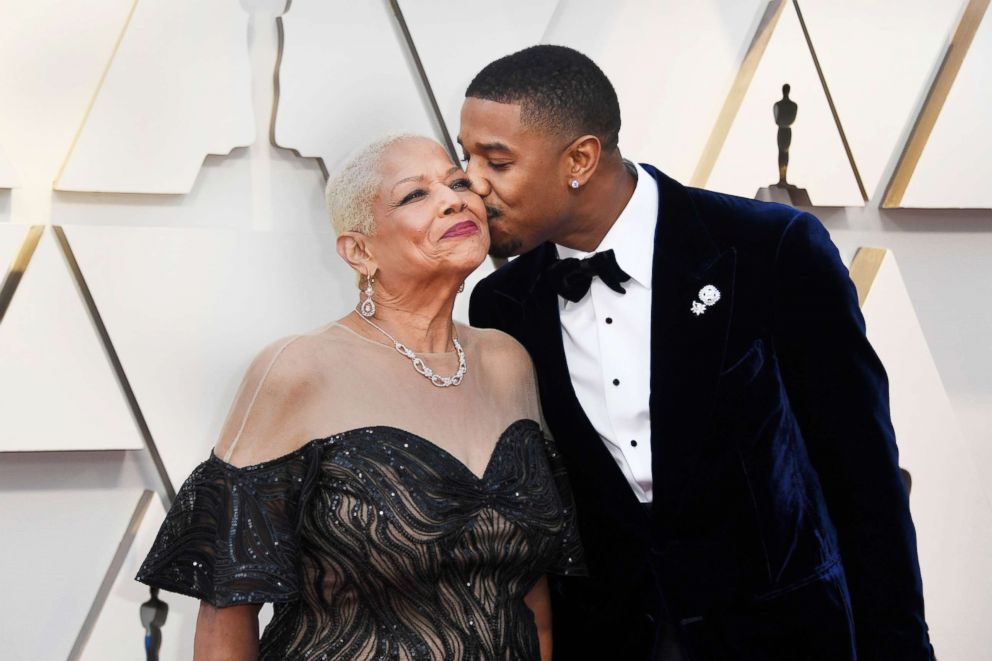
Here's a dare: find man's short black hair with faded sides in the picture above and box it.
[465,45,620,151]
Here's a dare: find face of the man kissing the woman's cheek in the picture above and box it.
[458,97,570,257]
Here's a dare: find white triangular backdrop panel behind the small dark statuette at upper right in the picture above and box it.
[706,3,864,206]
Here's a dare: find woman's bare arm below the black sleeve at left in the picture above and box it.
[193,601,262,661]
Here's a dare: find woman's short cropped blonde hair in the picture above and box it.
[324,133,430,236]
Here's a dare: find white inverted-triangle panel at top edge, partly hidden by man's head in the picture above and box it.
[400,0,558,140]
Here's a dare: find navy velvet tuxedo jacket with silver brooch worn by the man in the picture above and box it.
[470,165,932,661]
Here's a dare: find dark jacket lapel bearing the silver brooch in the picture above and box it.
[643,165,736,527]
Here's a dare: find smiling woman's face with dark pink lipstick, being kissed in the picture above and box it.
[368,138,489,290]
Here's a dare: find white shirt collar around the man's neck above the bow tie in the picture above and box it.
[555,161,659,289]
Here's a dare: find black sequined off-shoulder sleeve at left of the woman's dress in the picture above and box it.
[136,450,315,607]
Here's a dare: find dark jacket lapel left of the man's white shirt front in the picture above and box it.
[518,244,647,536]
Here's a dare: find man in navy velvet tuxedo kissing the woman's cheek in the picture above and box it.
[459,46,932,661]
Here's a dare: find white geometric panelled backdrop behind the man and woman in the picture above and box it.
[0,0,992,660]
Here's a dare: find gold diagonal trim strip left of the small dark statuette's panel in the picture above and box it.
[689,0,785,187]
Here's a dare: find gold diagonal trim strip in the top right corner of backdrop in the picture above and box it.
[881,0,992,209]
